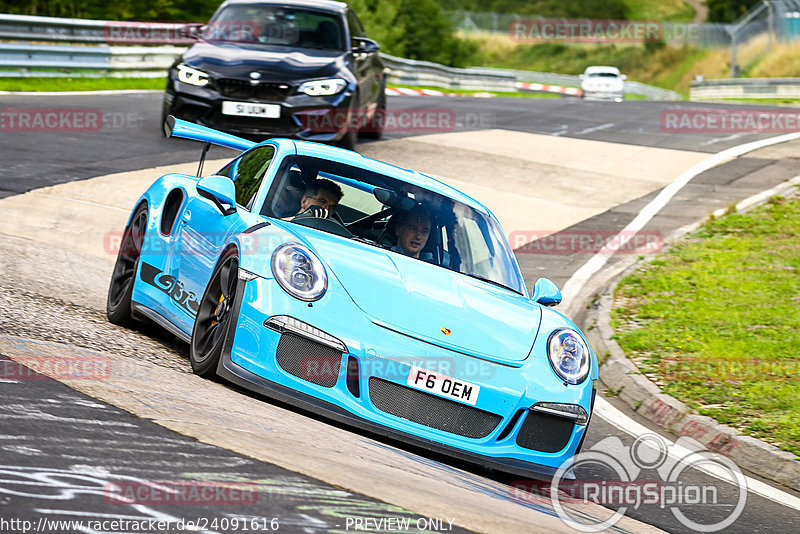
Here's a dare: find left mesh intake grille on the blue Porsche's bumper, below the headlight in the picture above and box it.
[275,333,342,388]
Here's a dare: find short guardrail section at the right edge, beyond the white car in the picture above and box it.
[689,78,800,101]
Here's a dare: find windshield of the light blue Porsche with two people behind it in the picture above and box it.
[256,155,525,294]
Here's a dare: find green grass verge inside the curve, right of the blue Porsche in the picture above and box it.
[612,195,800,455]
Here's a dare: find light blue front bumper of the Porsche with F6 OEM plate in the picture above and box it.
[217,270,594,479]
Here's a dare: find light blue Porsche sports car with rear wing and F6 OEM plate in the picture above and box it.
[107,117,598,478]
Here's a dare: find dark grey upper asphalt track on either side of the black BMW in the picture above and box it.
[0,92,785,198]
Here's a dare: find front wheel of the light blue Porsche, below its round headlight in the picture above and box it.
[189,249,239,378]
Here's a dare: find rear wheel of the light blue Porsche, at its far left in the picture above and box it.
[106,204,147,326]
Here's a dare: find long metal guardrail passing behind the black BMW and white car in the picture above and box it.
[0,15,680,100]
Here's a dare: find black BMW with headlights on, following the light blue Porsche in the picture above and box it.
[163,0,386,148]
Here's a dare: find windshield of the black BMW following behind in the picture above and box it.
[203,5,344,50]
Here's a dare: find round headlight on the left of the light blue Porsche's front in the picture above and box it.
[272,243,328,302]
